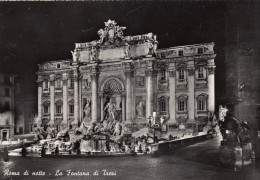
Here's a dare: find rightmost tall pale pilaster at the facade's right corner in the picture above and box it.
[208,59,215,112]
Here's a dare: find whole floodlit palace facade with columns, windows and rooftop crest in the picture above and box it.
[37,20,216,129]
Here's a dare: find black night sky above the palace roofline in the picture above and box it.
[0,2,225,94]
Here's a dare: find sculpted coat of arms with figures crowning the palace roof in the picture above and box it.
[98,19,126,44]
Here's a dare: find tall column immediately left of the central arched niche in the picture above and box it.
[90,73,98,121]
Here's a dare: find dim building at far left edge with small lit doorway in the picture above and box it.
[0,73,14,141]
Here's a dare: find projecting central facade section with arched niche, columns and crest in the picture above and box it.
[77,20,158,126]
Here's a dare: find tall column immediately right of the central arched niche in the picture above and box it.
[125,70,133,122]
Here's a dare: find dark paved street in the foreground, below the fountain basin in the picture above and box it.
[0,137,260,180]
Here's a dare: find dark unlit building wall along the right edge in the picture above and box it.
[223,2,260,157]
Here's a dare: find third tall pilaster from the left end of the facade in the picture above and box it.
[61,73,68,128]
